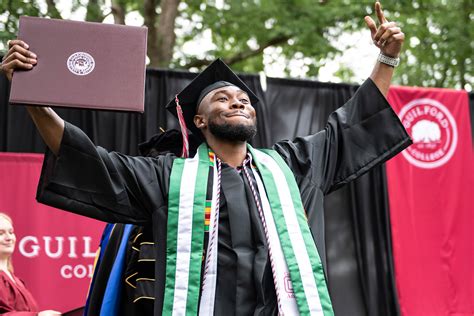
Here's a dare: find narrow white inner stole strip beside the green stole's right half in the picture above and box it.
[251,168,300,316]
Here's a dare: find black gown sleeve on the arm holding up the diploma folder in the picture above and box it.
[36,122,174,224]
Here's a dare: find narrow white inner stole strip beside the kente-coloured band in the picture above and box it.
[199,157,219,316]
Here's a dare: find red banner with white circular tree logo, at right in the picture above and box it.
[387,87,474,316]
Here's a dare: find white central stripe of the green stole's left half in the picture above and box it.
[172,155,199,316]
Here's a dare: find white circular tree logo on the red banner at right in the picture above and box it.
[398,99,458,169]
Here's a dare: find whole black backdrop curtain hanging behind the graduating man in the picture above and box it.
[0,69,474,316]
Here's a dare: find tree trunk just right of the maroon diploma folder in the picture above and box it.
[155,0,180,67]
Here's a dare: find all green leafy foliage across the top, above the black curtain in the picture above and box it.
[0,0,474,89]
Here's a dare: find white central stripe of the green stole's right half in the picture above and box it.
[255,150,323,315]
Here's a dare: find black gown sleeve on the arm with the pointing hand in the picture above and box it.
[274,78,411,194]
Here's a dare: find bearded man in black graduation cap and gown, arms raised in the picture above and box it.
[2,3,411,315]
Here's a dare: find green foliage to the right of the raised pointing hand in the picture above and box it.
[393,0,474,88]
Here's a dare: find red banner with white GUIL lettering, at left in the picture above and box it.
[0,153,105,312]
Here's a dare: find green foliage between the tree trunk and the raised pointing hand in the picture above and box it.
[175,0,367,74]
